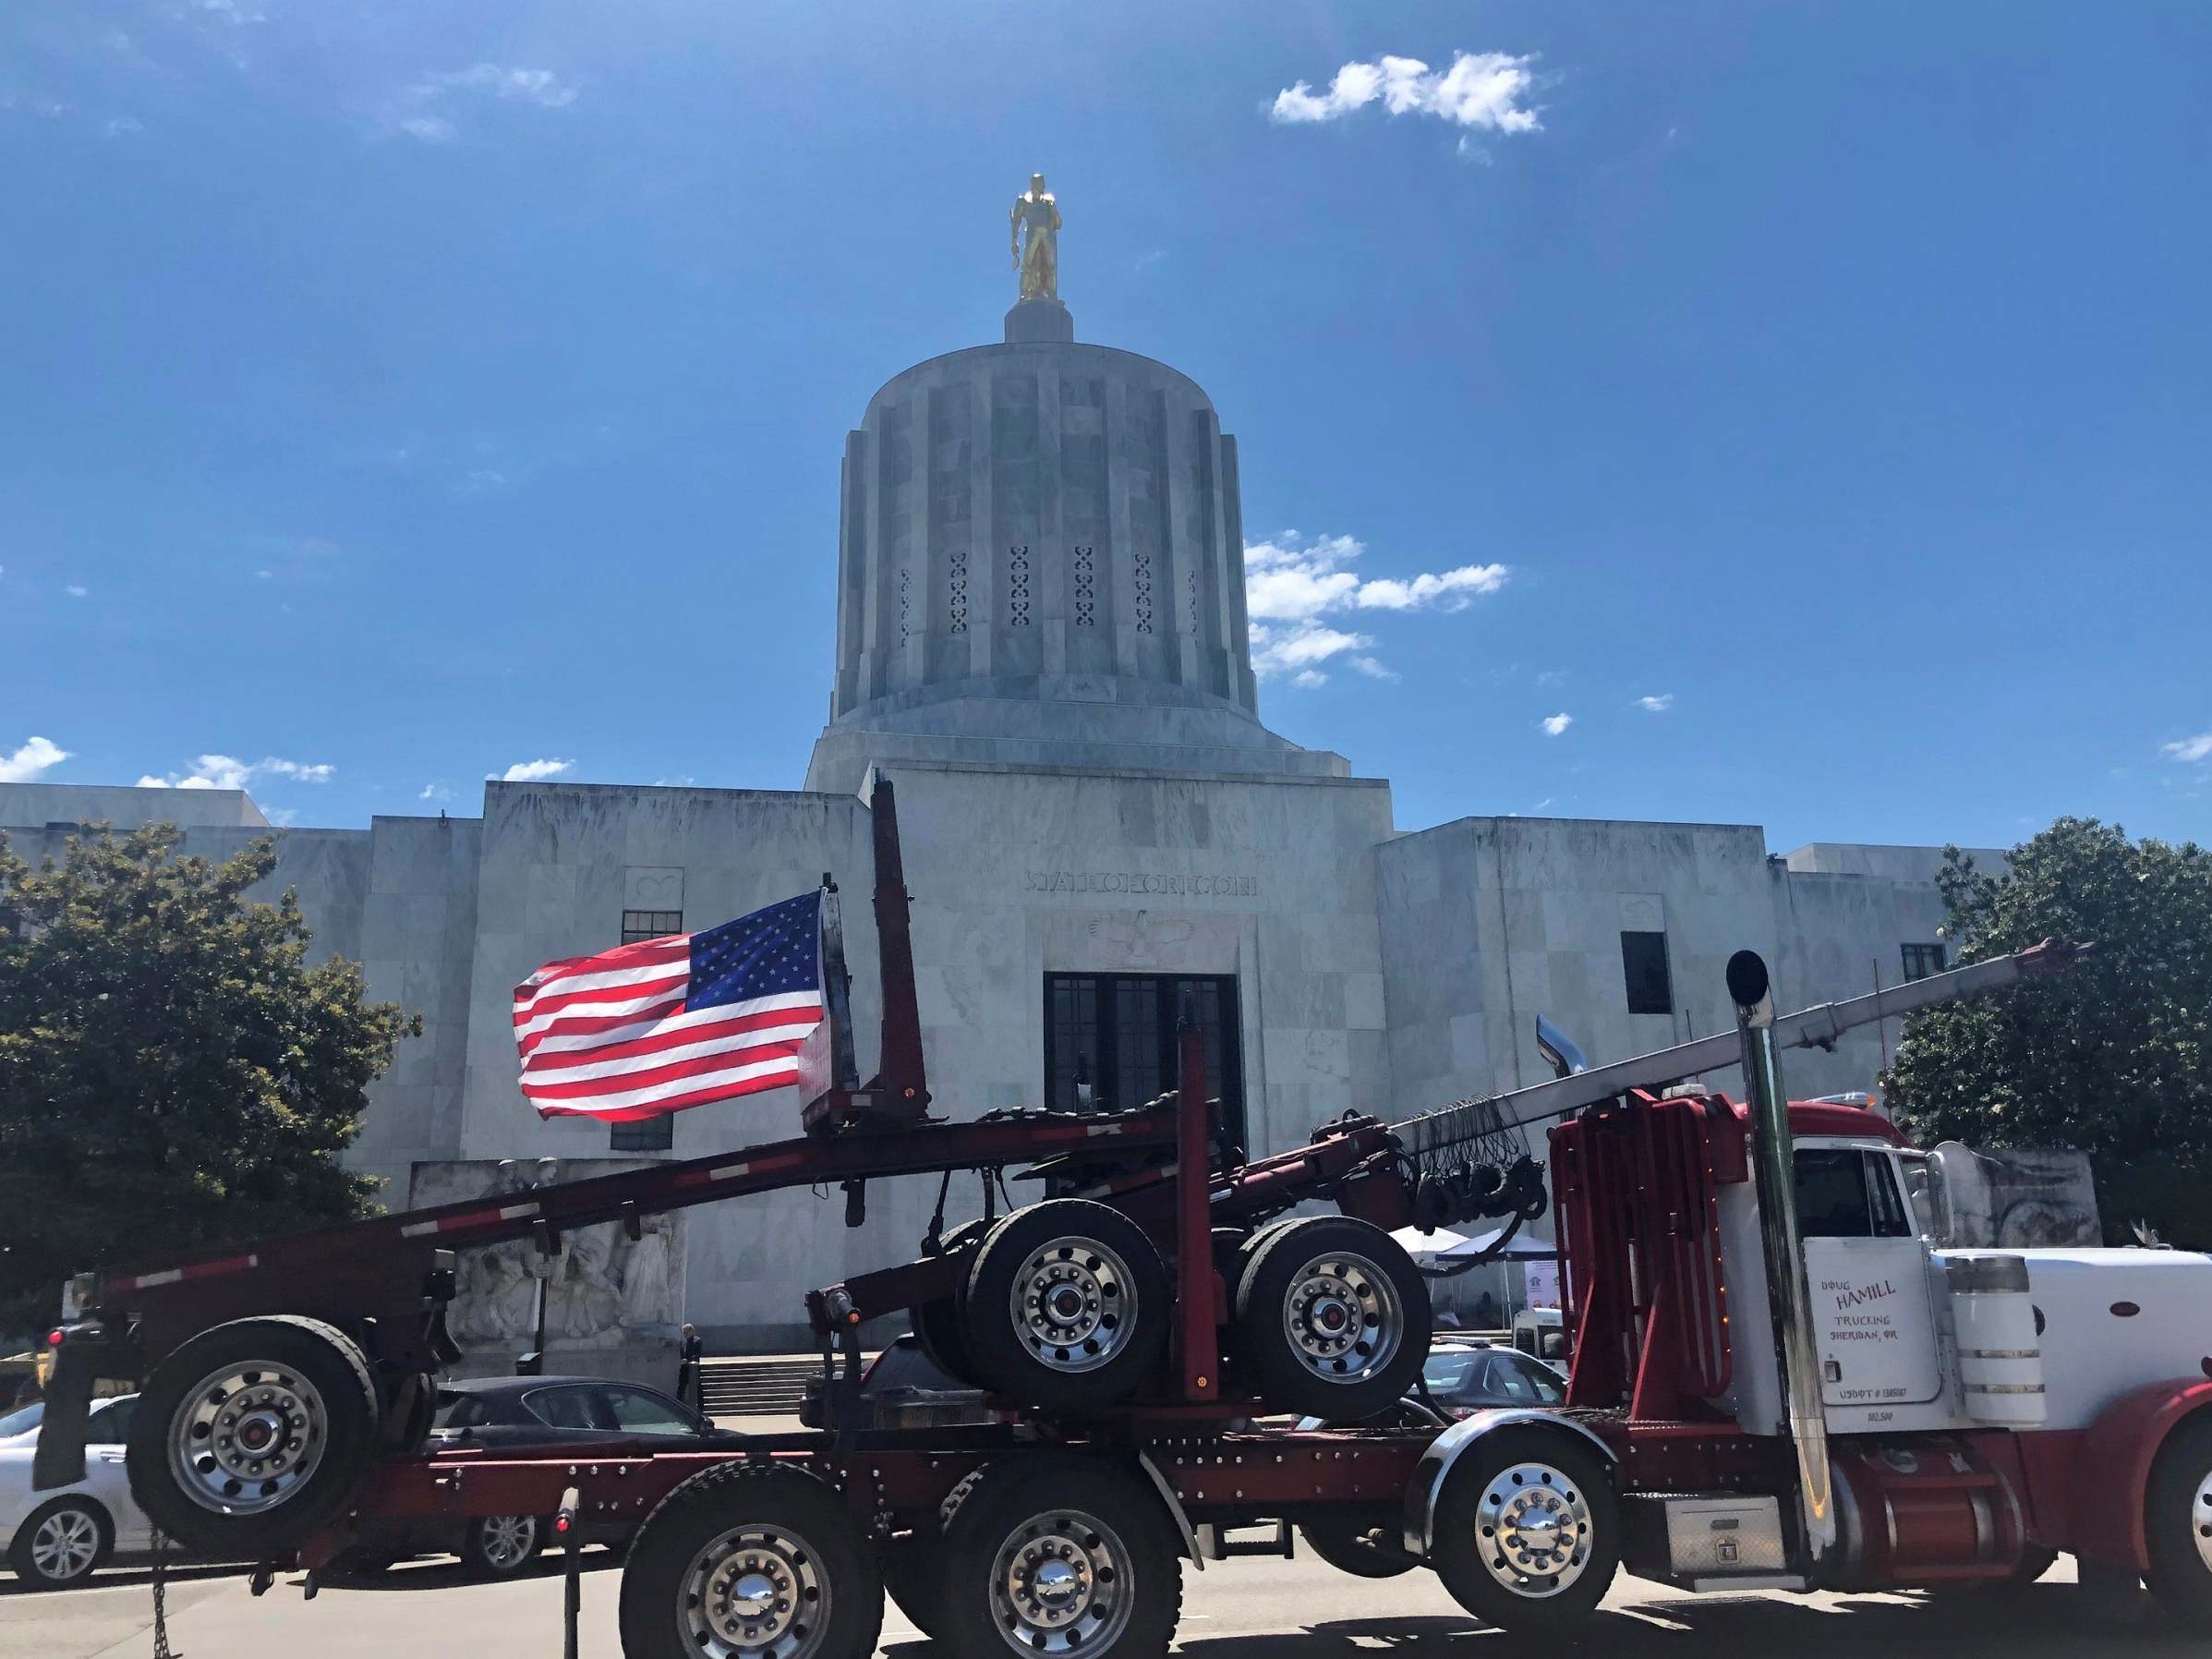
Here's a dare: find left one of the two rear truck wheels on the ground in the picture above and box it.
[622,1462,883,1659]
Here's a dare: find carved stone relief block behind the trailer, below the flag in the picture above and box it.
[409,1159,683,1351]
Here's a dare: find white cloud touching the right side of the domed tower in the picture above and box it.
[1245,531,1508,684]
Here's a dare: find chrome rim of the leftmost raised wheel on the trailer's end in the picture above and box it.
[168,1361,330,1515]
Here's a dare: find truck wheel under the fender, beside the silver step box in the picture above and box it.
[1429,1424,1622,1635]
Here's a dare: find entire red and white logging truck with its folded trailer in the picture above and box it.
[38,783,2212,1659]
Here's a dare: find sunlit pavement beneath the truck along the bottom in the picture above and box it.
[0,1551,2206,1659]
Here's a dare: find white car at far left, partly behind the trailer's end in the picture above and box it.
[0,1394,152,1591]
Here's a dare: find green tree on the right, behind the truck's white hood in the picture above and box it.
[1882,818,2212,1248]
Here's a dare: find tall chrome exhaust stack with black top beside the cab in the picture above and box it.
[1727,951,1836,1586]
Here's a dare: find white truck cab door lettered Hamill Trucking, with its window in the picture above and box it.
[1796,1145,1942,1407]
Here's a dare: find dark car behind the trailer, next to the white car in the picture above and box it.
[345,1375,745,1577]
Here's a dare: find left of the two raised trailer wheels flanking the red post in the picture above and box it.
[960,1199,1172,1411]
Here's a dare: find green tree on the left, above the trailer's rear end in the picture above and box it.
[0,825,422,1332]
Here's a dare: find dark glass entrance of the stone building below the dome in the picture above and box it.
[1044,974,1245,1145]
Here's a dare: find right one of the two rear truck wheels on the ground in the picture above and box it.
[937,1451,1183,1659]
